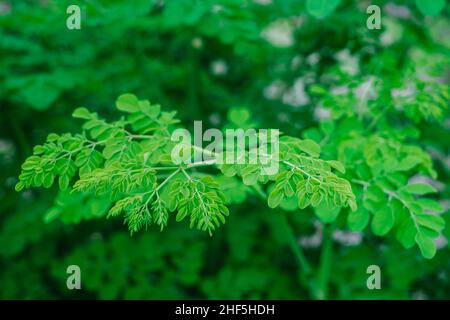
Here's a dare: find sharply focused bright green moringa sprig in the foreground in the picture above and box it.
[16,94,356,234]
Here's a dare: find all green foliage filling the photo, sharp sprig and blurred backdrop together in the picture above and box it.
[0,0,450,299]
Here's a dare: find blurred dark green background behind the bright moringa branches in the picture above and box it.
[0,0,450,299]
